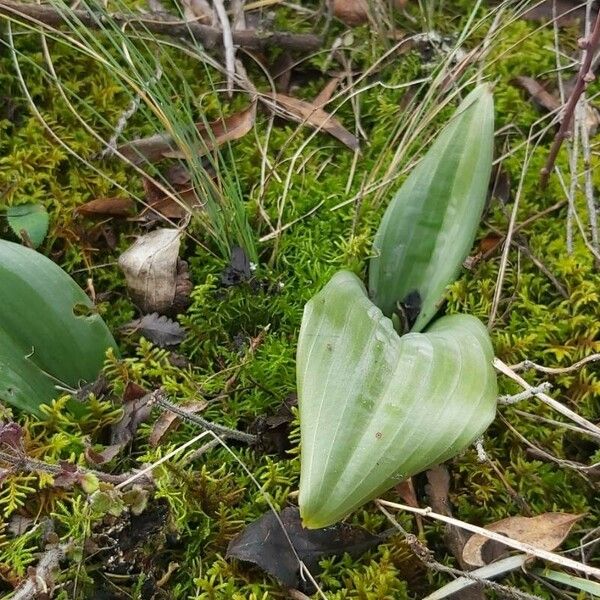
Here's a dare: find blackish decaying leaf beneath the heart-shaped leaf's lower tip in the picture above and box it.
[227,507,387,588]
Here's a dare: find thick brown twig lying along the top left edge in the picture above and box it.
[0,0,323,52]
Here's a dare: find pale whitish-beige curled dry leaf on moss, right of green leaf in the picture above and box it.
[119,229,182,313]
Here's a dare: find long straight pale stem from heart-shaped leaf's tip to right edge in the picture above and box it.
[376,499,600,579]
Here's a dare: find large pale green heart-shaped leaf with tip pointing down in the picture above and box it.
[297,271,497,528]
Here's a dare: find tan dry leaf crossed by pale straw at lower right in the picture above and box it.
[463,513,583,567]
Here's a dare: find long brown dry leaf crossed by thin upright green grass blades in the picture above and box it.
[117,103,256,165]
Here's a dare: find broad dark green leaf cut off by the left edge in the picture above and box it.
[0,240,115,414]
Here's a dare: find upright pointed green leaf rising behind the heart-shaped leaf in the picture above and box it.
[369,85,494,331]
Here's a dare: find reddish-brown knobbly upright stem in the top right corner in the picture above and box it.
[540,12,600,187]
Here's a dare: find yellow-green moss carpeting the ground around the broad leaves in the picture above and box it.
[0,2,600,600]
